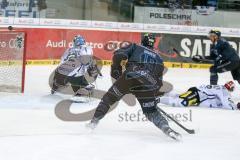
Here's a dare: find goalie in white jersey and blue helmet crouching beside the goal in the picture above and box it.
[51,35,98,97]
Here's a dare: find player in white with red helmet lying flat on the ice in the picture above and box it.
[160,81,240,110]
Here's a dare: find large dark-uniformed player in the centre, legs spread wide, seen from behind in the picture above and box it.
[87,33,181,140]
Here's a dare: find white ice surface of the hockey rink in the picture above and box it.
[0,66,240,160]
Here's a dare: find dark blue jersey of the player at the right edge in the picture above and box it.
[209,38,240,62]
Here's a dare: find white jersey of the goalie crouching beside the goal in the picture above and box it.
[58,45,93,77]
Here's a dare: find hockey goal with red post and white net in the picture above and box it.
[0,31,25,93]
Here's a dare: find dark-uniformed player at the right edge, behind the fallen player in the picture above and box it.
[193,30,240,85]
